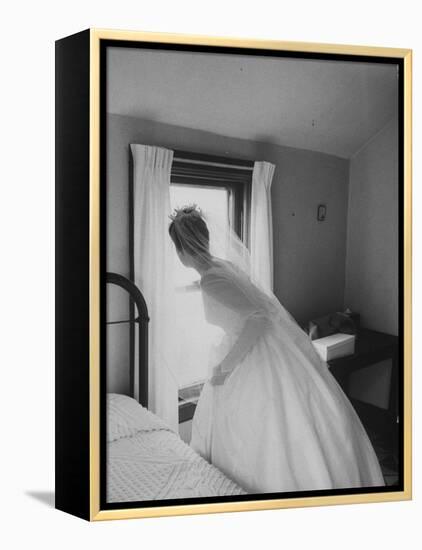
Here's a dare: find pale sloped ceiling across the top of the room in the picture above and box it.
[107,48,398,158]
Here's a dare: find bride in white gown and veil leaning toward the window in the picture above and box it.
[169,205,384,493]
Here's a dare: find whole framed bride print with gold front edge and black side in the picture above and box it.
[56,29,411,520]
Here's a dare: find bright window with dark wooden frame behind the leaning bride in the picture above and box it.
[170,152,253,422]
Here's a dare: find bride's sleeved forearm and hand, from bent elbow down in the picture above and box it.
[211,313,271,385]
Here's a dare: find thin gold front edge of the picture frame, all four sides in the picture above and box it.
[89,29,412,521]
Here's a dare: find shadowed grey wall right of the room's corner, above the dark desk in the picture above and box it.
[345,118,398,335]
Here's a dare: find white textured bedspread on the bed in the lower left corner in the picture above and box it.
[107,394,244,503]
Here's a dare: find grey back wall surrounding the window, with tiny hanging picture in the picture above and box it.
[107,115,349,391]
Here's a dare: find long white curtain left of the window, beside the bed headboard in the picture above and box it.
[131,144,178,431]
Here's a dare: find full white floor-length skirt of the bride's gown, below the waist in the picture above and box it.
[191,326,384,494]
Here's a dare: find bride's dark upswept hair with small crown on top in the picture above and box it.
[169,204,210,256]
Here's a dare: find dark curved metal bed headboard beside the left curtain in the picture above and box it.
[106,272,149,407]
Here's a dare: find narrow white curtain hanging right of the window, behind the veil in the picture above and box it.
[250,162,275,291]
